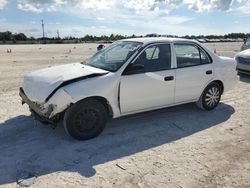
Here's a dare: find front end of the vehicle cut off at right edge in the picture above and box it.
[235,49,250,74]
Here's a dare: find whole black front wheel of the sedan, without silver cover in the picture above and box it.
[63,99,107,140]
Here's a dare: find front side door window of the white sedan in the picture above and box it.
[134,44,171,72]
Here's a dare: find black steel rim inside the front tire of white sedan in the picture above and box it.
[75,109,100,133]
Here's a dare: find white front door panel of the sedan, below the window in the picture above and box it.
[120,70,175,114]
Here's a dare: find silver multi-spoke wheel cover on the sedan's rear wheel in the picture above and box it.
[205,87,220,107]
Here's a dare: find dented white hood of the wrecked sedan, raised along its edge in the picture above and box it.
[22,63,108,103]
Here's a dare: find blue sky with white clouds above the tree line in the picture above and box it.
[0,0,250,37]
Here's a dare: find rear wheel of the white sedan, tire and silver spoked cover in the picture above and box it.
[197,82,222,110]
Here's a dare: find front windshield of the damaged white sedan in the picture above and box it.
[85,41,142,72]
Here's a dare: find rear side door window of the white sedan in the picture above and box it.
[174,44,210,68]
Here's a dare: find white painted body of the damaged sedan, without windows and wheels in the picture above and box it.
[22,38,238,118]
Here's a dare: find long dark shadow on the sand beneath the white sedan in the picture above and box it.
[0,103,234,185]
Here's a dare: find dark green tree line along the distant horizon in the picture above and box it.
[0,31,250,42]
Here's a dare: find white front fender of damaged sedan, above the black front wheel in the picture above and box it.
[46,74,120,118]
